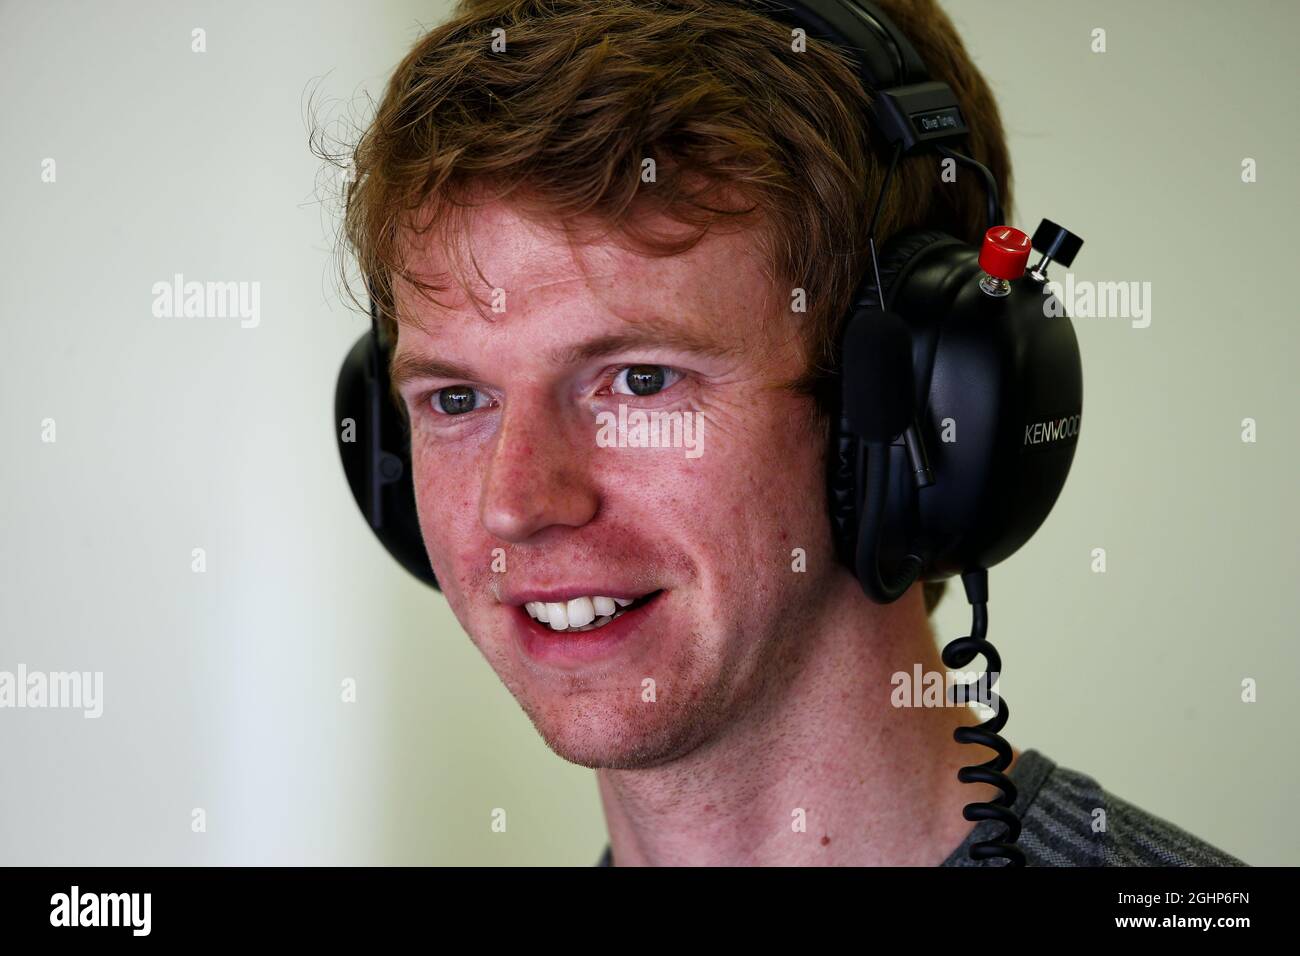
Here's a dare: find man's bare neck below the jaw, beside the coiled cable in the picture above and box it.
[597,579,998,866]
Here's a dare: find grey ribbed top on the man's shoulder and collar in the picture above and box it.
[597,750,1247,866]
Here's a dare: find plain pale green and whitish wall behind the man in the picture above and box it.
[0,0,1300,864]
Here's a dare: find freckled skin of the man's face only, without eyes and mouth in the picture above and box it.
[399,207,831,767]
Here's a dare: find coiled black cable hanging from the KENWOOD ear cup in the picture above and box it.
[943,568,1024,866]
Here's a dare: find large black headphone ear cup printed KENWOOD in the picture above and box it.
[828,226,1083,582]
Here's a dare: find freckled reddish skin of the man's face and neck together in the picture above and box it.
[397,204,1013,865]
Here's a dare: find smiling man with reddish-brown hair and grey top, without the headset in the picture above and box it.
[335,0,1239,866]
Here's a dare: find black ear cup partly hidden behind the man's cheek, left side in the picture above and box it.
[334,332,438,588]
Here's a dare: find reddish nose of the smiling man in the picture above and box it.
[478,395,599,542]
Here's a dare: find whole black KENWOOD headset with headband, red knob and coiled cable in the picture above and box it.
[334,0,1083,865]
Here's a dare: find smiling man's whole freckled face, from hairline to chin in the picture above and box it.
[394,204,842,767]
